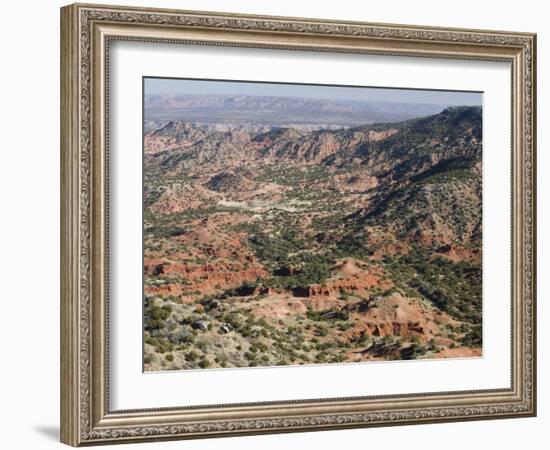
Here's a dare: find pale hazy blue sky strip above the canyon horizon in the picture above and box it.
[144,78,482,105]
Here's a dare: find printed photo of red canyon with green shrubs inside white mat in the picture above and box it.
[143,80,482,371]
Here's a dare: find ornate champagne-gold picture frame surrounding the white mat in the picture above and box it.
[61,4,536,446]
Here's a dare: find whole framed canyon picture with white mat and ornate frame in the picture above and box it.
[61,4,536,446]
